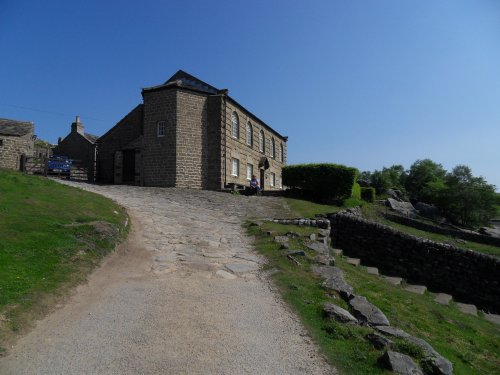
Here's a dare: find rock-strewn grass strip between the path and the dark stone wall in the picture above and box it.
[248,223,500,374]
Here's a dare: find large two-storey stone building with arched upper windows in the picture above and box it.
[97,70,287,190]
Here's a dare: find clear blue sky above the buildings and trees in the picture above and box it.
[0,0,500,188]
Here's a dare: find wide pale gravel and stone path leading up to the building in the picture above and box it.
[0,182,335,374]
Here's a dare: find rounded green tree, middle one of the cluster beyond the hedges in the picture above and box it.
[405,159,446,203]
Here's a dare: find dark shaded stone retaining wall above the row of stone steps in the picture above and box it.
[329,213,500,314]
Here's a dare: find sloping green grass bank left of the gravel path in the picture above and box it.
[0,170,127,352]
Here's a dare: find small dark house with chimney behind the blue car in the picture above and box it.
[53,116,98,170]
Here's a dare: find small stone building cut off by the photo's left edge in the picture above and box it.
[0,118,35,170]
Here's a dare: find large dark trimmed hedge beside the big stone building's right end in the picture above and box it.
[283,163,359,202]
